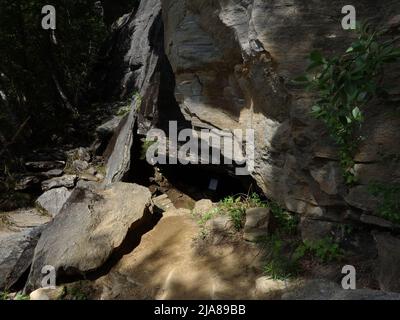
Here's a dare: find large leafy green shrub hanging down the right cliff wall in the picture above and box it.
[295,24,400,185]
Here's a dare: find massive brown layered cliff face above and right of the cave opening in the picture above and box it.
[162,0,400,221]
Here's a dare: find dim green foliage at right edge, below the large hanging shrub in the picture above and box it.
[369,183,400,224]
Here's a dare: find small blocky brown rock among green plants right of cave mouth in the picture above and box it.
[243,208,271,241]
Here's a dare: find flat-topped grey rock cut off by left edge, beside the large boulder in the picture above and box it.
[0,209,50,291]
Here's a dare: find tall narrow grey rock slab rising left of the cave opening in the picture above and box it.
[97,0,163,185]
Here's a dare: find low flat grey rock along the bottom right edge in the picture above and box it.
[282,279,400,300]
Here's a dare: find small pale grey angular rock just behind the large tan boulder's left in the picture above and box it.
[36,187,72,217]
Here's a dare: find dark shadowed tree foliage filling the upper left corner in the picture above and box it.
[0,0,107,153]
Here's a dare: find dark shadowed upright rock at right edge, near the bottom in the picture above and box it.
[374,233,400,292]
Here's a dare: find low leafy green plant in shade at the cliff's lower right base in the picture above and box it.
[293,237,343,263]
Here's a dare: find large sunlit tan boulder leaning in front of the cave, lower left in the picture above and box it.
[26,183,151,291]
